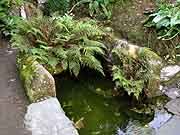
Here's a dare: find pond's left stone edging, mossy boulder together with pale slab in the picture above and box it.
[18,57,78,135]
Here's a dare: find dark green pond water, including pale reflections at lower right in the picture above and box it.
[55,73,173,135]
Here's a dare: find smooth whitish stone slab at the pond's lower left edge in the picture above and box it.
[25,98,78,135]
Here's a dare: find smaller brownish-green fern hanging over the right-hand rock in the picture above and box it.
[112,48,151,99]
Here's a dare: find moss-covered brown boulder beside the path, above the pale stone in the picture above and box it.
[19,57,56,102]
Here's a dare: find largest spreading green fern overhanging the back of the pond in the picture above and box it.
[11,15,105,76]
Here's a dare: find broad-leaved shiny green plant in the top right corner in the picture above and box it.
[145,2,180,40]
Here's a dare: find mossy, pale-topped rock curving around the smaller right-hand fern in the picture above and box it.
[112,39,162,98]
